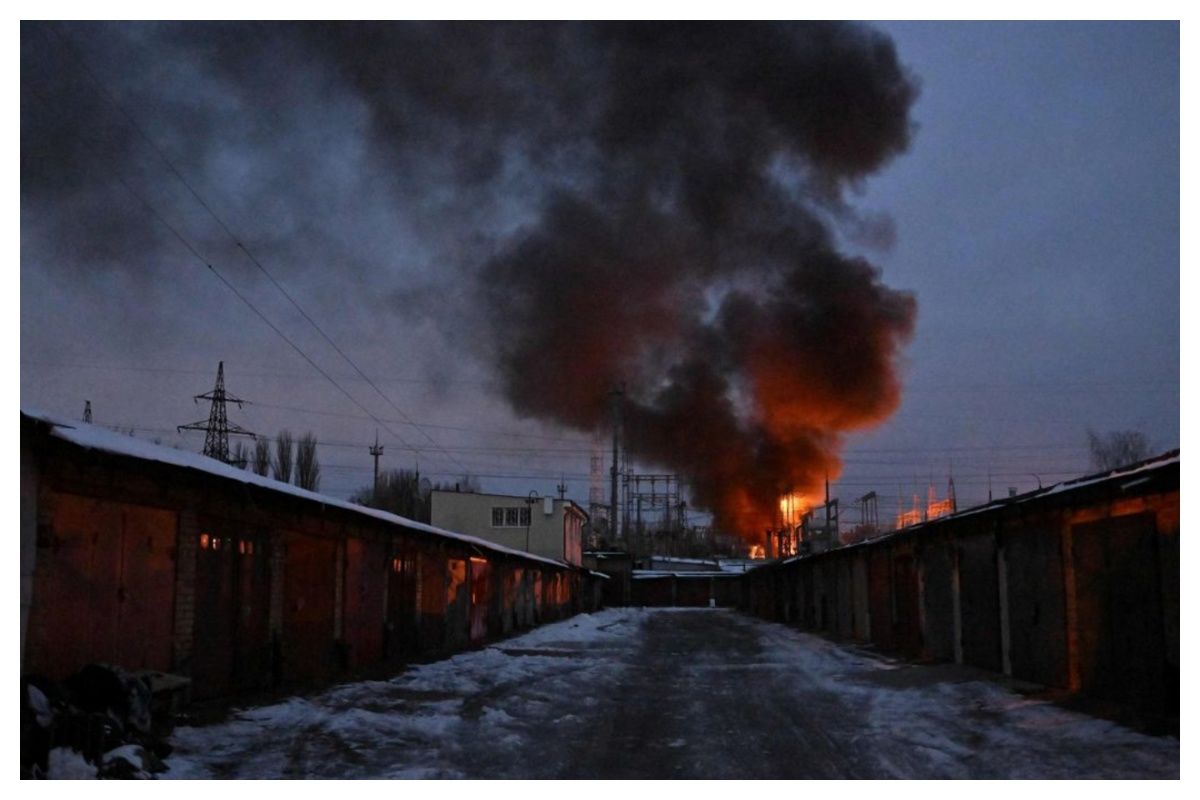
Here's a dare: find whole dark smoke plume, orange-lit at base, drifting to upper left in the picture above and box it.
[22,23,917,534]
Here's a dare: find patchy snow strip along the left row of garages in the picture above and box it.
[162,609,644,778]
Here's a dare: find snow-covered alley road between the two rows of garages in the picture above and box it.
[166,608,1180,778]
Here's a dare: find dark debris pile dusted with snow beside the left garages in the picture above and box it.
[20,663,190,778]
